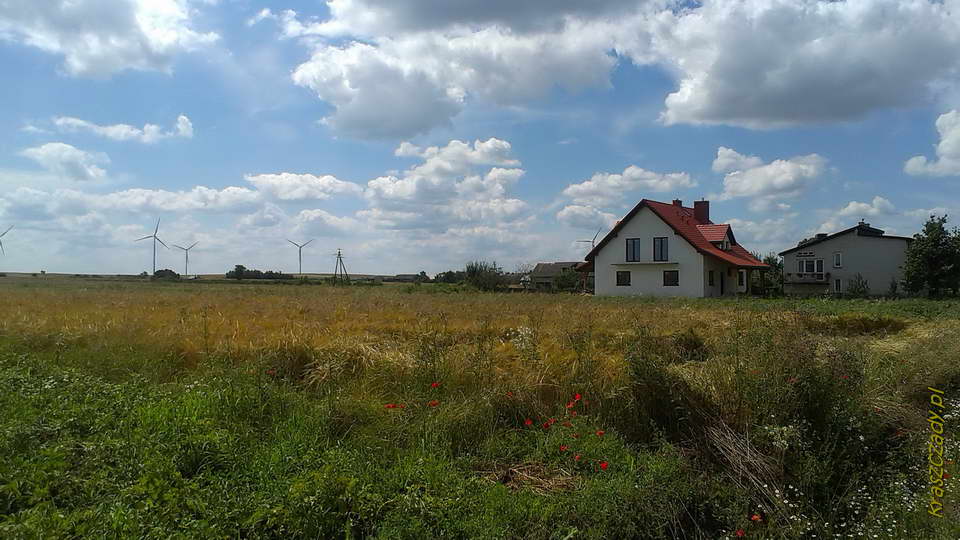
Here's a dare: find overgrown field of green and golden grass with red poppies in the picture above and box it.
[0,284,960,539]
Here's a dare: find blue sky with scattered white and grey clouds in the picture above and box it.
[0,0,960,274]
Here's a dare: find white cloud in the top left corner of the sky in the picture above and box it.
[0,0,219,77]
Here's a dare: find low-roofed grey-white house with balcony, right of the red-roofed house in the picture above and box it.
[780,221,913,295]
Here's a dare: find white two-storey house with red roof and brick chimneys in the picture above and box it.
[578,199,769,297]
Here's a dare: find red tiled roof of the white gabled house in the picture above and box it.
[586,199,768,268]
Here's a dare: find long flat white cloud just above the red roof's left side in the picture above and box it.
[563,165,697,206]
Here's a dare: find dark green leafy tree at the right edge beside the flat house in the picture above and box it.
[903,215,960,297]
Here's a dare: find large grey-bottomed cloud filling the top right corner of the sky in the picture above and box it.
[640,0,960,128]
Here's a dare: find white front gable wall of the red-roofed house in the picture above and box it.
[593,208,704,297]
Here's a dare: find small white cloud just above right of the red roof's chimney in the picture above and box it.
[713,147,827,212]
